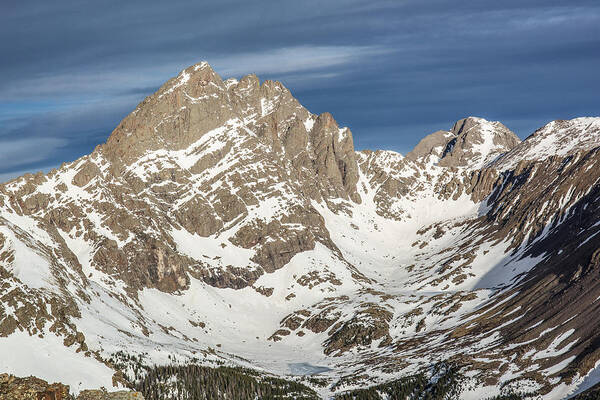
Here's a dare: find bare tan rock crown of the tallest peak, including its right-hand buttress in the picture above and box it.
[100,62,360,202]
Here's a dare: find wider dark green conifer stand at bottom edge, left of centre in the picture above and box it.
[135,365,319,400]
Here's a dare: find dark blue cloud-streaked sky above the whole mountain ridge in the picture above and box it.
[0,0,600,180]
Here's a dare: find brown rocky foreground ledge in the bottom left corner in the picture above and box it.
[0,374,144,400]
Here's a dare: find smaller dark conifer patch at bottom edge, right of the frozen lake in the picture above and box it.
[335,364,464,400]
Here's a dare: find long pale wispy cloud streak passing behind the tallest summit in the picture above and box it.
[0,46,392,102]
